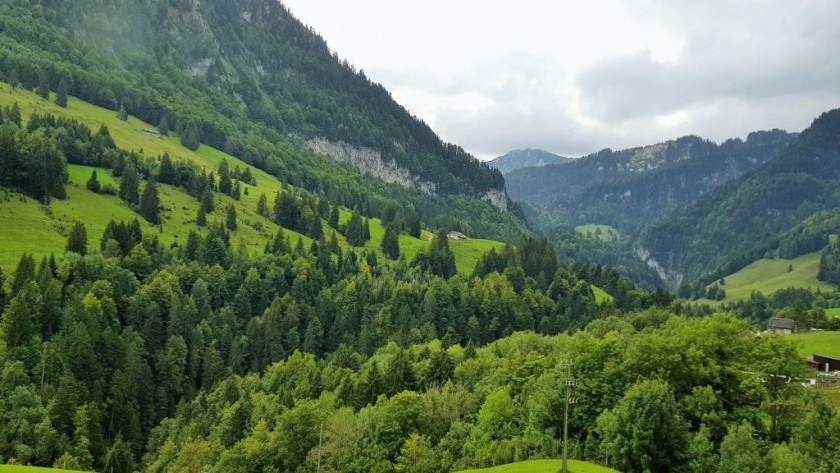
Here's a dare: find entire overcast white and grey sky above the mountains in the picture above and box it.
[282,0,840,159]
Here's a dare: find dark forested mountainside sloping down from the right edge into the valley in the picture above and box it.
[639,110,840,283]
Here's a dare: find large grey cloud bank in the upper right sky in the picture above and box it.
[577,2,840,123]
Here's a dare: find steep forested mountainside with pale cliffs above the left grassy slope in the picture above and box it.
[0,0,524,240]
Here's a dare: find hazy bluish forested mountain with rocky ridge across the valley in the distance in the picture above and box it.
[506,130,797,231]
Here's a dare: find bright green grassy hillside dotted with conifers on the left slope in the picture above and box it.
[0,83,503,274]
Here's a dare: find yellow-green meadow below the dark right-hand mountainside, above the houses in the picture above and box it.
[703,252,835,302]
